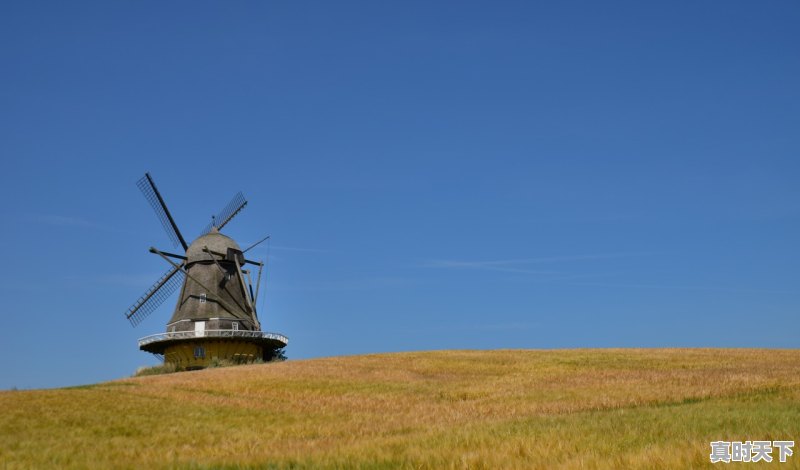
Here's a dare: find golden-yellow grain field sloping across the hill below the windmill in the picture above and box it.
[0,349,800,469]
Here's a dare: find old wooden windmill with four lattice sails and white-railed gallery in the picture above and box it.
[125,173,289,369]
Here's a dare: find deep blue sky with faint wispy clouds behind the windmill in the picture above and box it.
[0,1,800,388]
